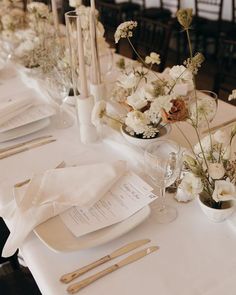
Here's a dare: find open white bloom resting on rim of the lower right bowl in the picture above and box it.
[212,180,236,202]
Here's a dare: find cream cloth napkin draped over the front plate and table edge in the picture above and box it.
[0,161,126,257]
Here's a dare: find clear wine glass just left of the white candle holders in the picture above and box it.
[44,67,74,129]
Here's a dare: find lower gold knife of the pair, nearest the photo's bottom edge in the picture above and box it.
[67,246,159,294]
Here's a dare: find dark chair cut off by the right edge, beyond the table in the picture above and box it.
[213,39,236,105]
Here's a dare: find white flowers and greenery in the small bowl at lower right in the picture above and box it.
[184,126,236,208]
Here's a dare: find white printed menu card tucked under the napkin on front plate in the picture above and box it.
[60,171,157,237]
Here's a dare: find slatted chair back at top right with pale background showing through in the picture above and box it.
[195,0,224,21]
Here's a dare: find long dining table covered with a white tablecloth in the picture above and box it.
[0,57,236,295]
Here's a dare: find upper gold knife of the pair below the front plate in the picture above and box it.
[60,239,150,284]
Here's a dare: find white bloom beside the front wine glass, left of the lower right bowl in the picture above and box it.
[179,173,203,200]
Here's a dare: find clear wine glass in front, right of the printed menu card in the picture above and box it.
[144,140,181,223]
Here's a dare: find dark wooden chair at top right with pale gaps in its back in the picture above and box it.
[193,0,224,57]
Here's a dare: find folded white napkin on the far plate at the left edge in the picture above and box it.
[0,97,34,125]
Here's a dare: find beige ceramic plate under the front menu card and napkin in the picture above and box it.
[34,206,150,252]
